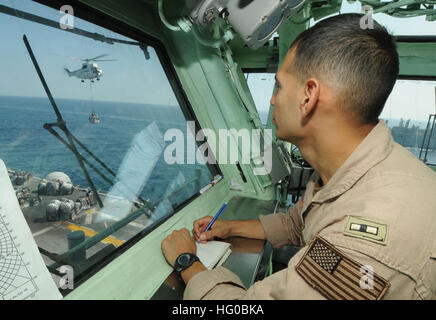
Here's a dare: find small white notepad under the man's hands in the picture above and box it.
[197,241,232,270]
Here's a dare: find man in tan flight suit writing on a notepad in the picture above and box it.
[162,14,436,299]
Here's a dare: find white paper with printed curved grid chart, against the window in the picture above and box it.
[0,159,62,300]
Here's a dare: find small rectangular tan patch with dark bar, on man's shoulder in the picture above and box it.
[344,216,388,245]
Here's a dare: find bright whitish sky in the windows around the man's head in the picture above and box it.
[248,1,436,121]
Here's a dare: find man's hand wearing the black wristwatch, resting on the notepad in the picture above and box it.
[161,228,197,267]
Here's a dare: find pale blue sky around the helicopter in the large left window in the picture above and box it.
[0,0,178,105]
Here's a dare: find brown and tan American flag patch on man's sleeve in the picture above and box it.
[295,236,390,300]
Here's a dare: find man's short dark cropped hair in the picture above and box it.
[288,13,399,124]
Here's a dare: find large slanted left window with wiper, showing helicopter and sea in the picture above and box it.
[0,0,219,285]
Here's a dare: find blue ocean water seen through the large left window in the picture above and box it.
[0,96,214,204]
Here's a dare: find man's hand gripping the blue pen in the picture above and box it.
[193,216,231,243]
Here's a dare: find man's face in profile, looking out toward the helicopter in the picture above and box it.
[271,51,303,143]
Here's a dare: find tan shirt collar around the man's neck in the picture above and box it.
[303,120,394,212]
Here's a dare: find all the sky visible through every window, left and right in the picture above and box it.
[0,0,436,121]
